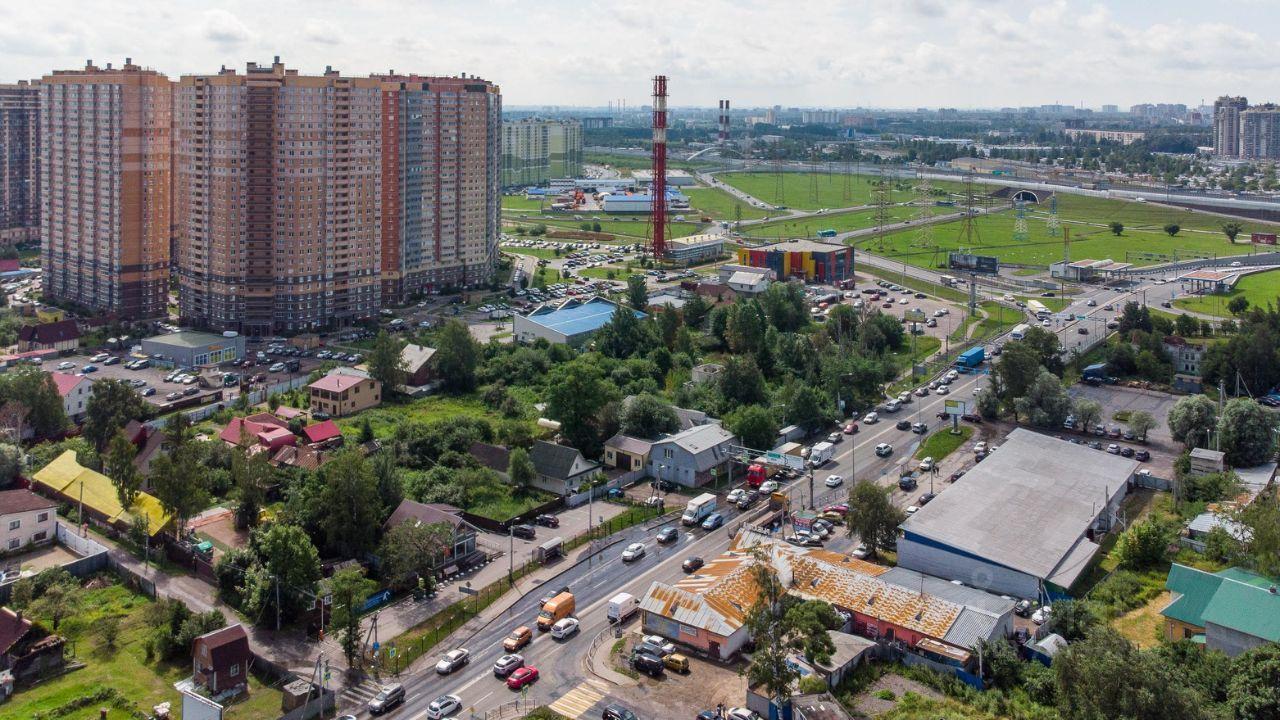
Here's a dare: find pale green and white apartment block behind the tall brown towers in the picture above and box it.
[502,118,582,187]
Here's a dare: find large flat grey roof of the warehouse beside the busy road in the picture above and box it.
[902,428,1138,587]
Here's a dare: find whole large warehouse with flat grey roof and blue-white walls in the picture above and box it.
[897,428,1138,598]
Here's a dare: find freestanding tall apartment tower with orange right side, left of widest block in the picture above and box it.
[40,59,173,319]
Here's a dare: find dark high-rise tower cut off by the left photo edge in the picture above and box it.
[0,81,40,246]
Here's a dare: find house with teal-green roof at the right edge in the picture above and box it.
[1160,562,1280,657]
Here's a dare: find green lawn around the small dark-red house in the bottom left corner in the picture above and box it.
[8,575,280,720]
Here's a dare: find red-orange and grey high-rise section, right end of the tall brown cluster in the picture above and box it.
[375,74,501,305]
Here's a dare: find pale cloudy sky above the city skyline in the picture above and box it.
[0,0,1280,108]
